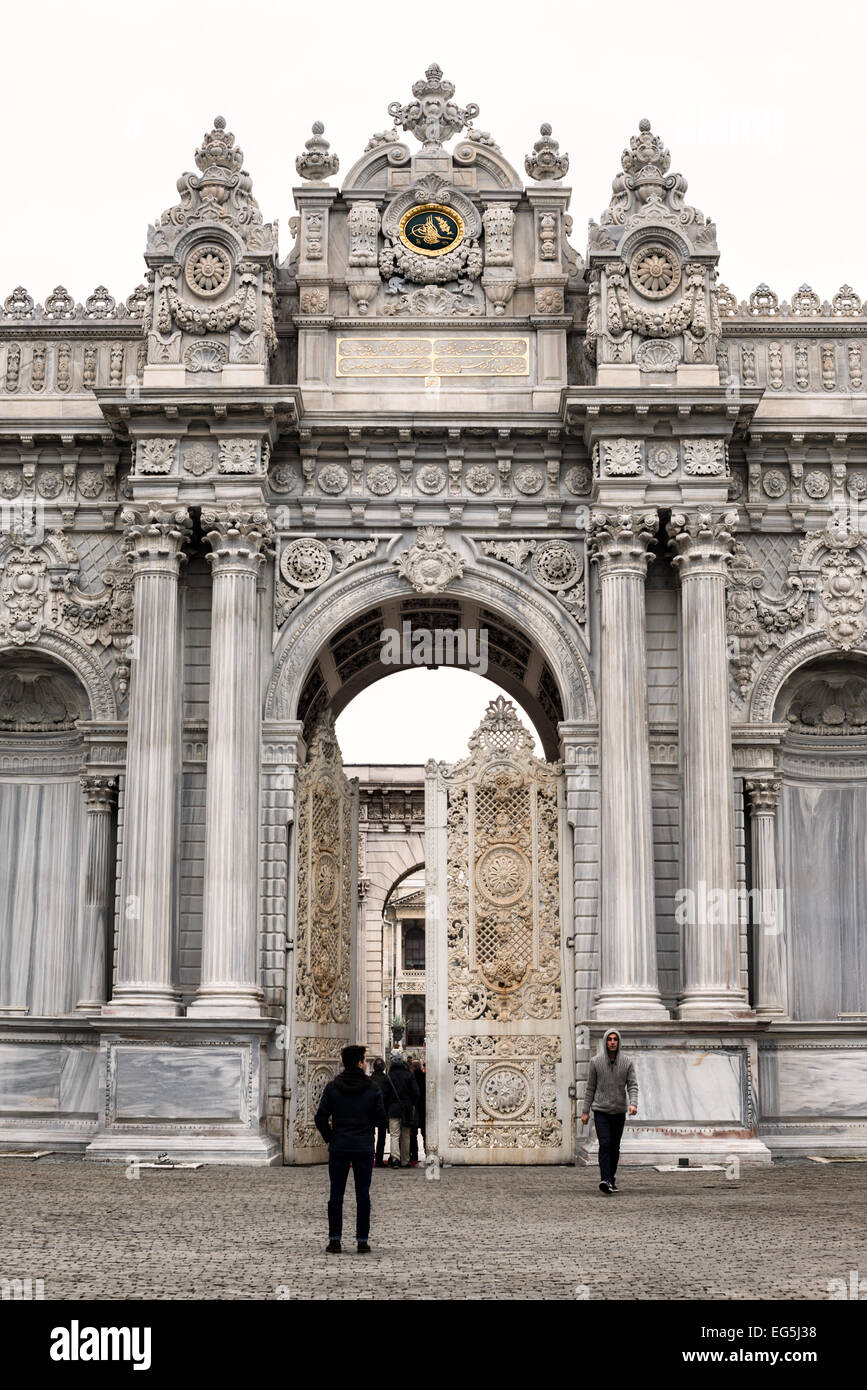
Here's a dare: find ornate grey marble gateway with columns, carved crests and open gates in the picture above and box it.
[0,64,867,1163]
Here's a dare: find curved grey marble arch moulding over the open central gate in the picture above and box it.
[264,563,597,742]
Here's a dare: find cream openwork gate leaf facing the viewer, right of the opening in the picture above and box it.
[427,696,572,1163]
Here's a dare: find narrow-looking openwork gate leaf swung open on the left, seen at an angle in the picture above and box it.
[290,713,358,1163]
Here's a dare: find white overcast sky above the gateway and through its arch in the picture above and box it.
[0,0,867,762]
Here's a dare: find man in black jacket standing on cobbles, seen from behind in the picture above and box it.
[314,1047,386,1255]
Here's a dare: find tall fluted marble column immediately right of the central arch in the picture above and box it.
[591,507,668,1022]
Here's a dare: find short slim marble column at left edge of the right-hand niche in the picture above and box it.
[746,777,786,1019]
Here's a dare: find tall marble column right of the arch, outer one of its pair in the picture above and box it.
[668,507,752,1019]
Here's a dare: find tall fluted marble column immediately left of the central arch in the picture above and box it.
[188,507,272,1017]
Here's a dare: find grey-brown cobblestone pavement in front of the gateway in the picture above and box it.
[0,1156,867,1300]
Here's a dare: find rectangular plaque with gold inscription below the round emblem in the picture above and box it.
[336,335,529,377]
